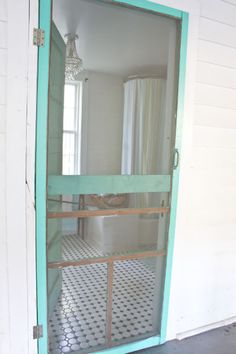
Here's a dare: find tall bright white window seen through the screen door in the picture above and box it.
[62,81,82,175]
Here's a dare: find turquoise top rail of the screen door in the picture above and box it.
[112,0,182,19]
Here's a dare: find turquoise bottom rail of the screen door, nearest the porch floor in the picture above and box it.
[94,336,160,354]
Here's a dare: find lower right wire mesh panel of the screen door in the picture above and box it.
[112,257,165,345]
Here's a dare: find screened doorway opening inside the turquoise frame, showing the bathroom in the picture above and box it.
[36,0,188,354]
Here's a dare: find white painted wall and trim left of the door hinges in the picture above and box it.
[0,0,37,354]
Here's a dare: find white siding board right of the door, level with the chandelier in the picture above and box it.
[198,40,236,68]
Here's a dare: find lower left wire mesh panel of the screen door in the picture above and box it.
[49,263,107,354]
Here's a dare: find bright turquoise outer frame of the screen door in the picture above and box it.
[36,0,189,354]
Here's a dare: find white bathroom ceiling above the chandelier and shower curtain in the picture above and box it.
[53,0,176,77]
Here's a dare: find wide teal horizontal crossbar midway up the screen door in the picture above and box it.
[48,175,170,195]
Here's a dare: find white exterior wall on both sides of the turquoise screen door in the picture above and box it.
[0,0,236,354]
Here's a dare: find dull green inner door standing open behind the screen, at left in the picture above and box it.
[47,22,66,317]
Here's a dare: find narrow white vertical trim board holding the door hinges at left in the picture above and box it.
[26,0,39,354]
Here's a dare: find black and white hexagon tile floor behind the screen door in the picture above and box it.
[48,235,159,354]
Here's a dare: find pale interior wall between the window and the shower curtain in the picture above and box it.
[84,72,124,175]
